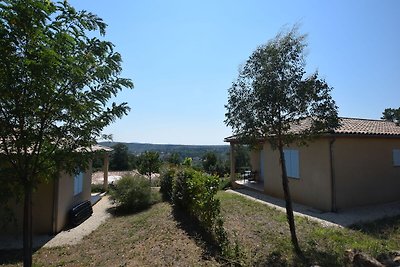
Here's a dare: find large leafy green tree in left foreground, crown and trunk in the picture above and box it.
[0,0,133,266]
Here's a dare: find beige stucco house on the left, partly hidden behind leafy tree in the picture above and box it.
[0,145,112,236]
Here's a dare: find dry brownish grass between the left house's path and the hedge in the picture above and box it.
[0,203,218,266]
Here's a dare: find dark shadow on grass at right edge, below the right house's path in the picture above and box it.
[350,216,400,239]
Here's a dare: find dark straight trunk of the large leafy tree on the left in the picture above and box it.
[23,185,32,267]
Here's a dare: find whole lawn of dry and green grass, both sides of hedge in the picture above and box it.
[0,191,400,266]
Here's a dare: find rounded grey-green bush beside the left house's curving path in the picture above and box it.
[110,175,159,212]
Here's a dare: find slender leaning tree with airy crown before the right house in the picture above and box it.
[225,27,338,255]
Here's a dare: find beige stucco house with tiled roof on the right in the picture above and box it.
[225,118,400,211]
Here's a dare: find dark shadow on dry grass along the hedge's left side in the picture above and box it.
[172,208,219,259]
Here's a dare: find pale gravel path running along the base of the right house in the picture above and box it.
[228,189,400,227]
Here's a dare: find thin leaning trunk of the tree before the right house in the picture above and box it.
[278,144,302,256]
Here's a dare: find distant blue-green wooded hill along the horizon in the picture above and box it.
[100,142,229,159]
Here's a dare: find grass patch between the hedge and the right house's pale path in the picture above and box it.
[219,192,400,266]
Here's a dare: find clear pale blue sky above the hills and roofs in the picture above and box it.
[70,0,400,144]
